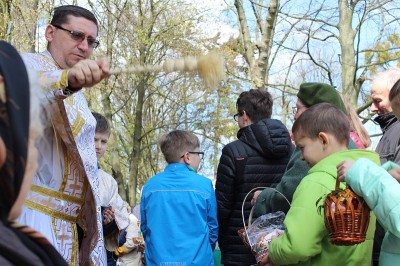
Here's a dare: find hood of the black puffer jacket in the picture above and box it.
[237,118,294,159]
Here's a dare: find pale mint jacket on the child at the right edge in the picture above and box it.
[346,159,400,266]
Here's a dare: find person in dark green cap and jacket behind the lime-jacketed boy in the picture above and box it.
[252,82,357,217]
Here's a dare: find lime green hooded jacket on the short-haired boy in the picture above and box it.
[269,149,380,266]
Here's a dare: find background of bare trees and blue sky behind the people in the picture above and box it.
[0,0,400,206]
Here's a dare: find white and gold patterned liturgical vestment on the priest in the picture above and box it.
[19,51,107,266]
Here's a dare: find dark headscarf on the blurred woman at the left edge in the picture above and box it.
[0,41,30,222]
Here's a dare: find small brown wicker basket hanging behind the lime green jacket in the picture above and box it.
[324,180,370,246]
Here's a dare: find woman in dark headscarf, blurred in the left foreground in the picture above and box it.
[0,41,67,266]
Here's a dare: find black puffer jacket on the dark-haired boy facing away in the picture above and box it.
[215,119,294,266]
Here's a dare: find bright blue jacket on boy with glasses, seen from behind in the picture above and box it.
[140,163,218,266]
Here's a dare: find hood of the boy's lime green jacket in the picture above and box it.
[308,149,381,180]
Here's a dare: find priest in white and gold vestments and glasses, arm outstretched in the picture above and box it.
[20,5,108,265]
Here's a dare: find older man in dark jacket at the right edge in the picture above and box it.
[371,68,400,266]
